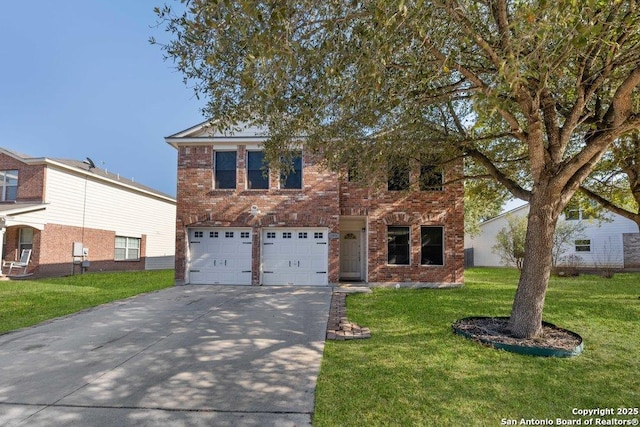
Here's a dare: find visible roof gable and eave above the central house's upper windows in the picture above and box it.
[164,120,268,148]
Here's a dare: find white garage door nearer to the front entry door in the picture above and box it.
[262,228,328,285]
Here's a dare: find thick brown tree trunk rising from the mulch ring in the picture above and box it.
[509,195,559,338]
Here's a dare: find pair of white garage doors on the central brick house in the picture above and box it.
[188,228,328,285]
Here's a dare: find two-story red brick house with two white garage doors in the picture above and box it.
[165,123,464,285]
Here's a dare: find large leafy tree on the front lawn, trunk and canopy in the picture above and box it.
[158,0,640,337]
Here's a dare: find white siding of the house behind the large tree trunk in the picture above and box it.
[465,205,638,267]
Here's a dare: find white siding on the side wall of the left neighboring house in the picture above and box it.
[45,167,176,268]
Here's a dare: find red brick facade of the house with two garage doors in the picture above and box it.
[176,143,464,285]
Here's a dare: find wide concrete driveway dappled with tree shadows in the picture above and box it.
[0,285,331,426]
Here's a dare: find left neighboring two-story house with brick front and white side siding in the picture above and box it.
[0,148,176,276]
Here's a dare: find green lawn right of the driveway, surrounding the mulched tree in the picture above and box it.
[314,268,640,426]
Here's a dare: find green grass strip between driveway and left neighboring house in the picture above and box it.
[0,270,173,333]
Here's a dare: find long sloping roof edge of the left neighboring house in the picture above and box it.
[0,147,176,203]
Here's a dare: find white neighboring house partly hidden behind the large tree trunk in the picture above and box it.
[464,204,640,268]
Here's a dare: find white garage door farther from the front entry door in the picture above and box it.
[189,228,252,285]
